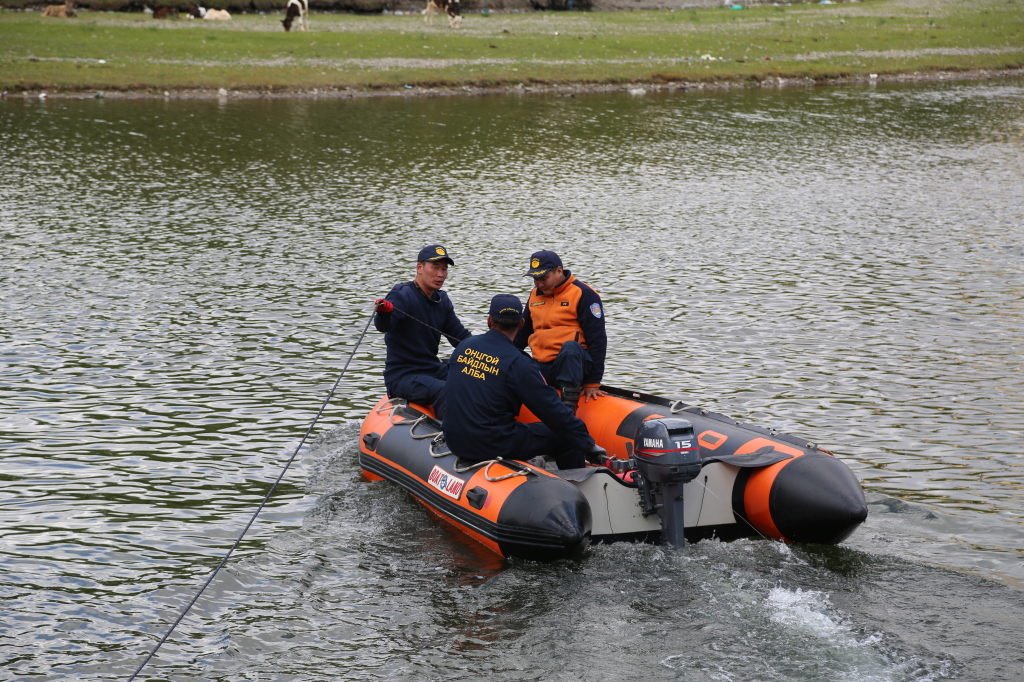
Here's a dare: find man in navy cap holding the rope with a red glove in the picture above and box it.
[374,244,470,419]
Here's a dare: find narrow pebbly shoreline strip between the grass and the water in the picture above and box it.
[9,67,1024,100]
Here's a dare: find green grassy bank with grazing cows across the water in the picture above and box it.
[0,0,1024,93]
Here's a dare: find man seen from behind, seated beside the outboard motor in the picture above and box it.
[441,294,604,469]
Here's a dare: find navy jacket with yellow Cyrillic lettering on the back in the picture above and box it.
[441,329,594,460]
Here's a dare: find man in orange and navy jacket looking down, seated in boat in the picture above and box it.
[514,251,608,410]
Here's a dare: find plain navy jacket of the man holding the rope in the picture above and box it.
[374,282,470,385]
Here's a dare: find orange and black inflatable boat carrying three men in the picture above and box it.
[359,386,867,560]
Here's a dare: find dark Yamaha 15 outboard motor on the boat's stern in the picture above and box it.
[633,418,700,547]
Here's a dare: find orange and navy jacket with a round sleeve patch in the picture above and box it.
[515,270,608,386]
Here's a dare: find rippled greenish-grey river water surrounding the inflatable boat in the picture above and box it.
[0,81,1024,681]
